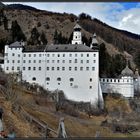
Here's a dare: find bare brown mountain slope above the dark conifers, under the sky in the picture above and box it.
[0,4,140,74]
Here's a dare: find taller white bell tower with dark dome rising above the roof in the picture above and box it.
[72,24,82,44]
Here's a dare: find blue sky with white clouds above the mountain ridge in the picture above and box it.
[4,2,140,34]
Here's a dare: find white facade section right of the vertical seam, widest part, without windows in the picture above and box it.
[45,52,99,101]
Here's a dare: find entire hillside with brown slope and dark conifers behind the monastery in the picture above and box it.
[0,4,140,77]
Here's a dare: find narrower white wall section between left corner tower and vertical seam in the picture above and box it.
[22,52,46,87]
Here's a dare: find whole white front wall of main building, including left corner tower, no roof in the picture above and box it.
[4,43,99,103]
